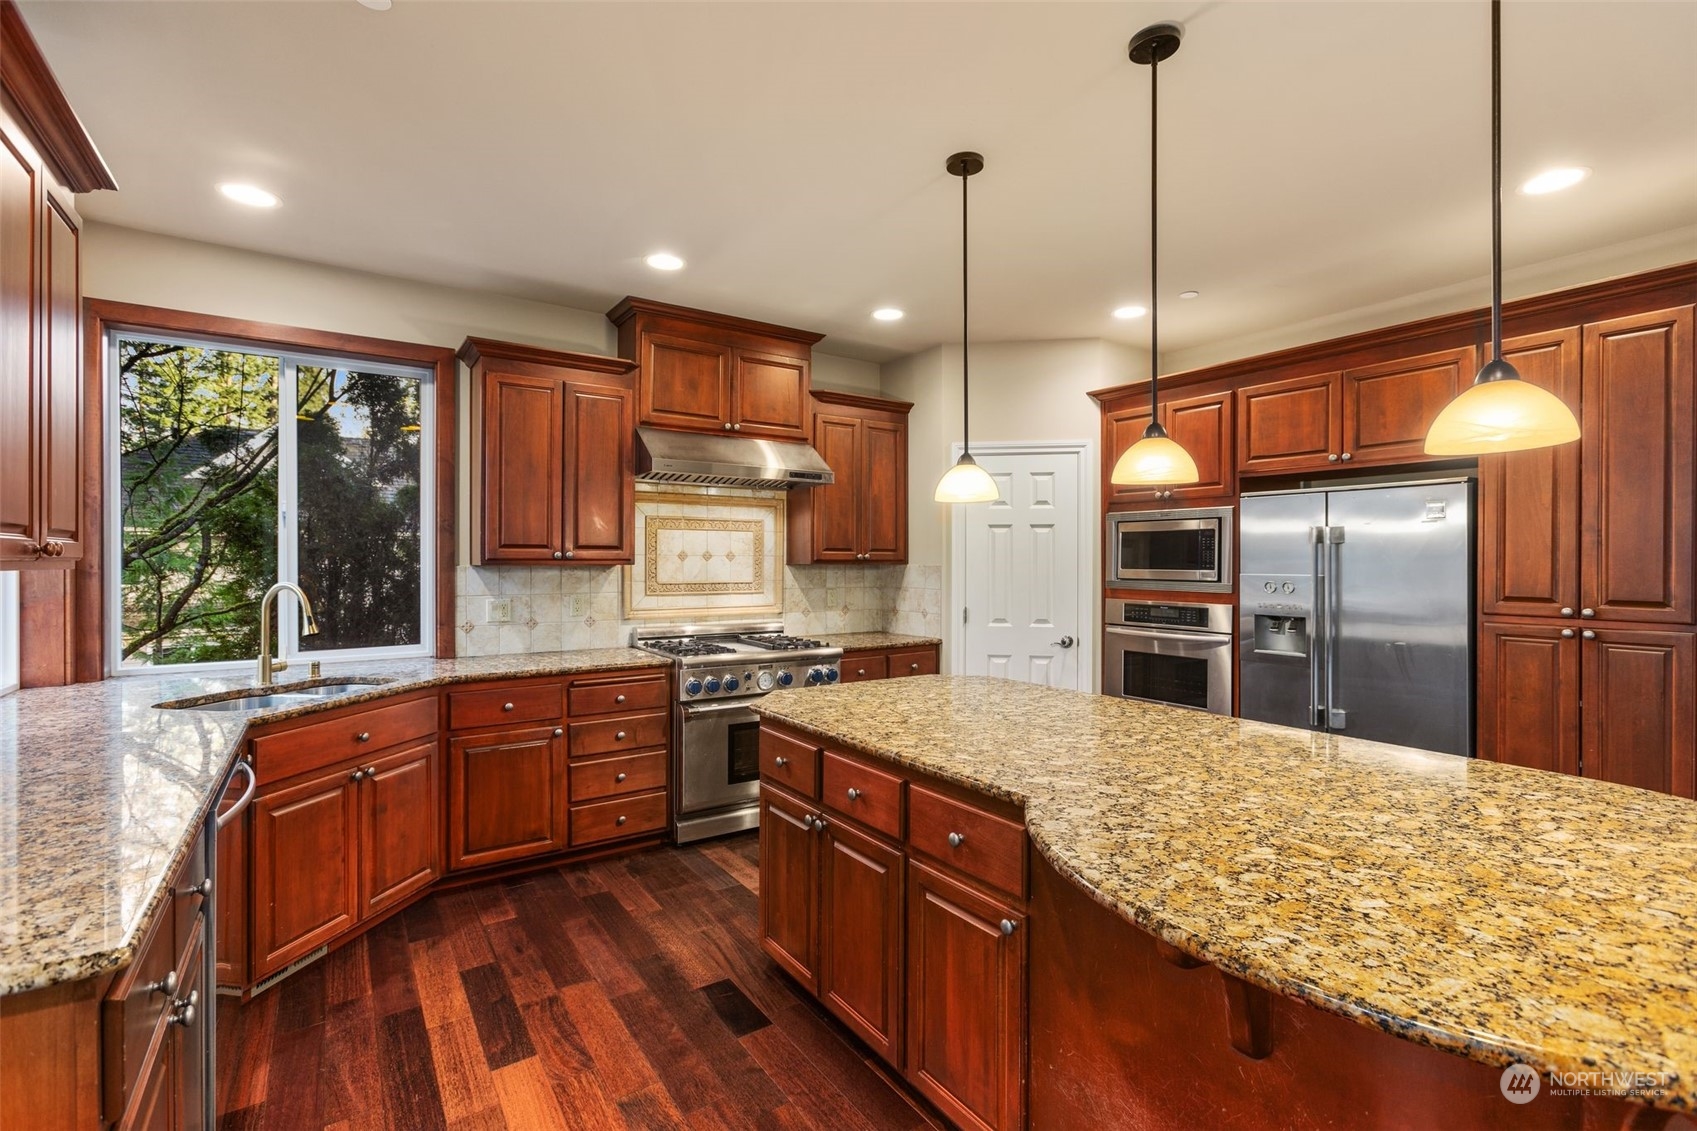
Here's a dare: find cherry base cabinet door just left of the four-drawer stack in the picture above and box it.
[448,727,567,871]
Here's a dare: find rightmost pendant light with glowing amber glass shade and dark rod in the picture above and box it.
[1425,0,1580,455]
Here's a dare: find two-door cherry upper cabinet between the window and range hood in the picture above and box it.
[460,338,636,566]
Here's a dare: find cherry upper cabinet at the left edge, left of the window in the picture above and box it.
[0,3,117,569]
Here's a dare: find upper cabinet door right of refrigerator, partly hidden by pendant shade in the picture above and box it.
[1478,328,1580,618]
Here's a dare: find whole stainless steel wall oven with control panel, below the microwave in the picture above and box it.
[1101,599,1232,715]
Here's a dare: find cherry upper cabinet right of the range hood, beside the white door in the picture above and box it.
[787,391,913,566]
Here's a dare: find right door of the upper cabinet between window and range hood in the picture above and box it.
[563,380,636,566]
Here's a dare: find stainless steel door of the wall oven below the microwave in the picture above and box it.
[1101,625,1232,715]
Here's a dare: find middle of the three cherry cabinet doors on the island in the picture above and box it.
[820,820,905,1066]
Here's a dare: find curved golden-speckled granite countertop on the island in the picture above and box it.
[755,676,1697,1111]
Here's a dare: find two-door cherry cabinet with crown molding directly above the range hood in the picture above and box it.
[608,299,823,442]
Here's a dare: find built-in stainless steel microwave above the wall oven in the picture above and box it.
[1106,506,1234,593]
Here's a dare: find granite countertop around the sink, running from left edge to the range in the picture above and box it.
[0,649,670,993]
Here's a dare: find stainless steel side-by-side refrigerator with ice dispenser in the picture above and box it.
[1237,479,1473,756]
